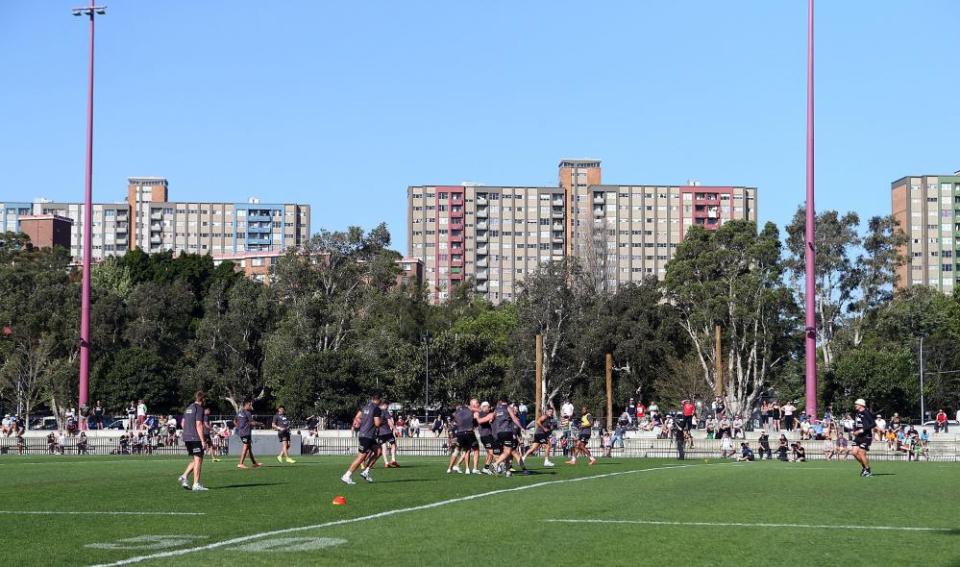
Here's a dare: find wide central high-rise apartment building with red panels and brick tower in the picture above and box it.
[407,159,757,303]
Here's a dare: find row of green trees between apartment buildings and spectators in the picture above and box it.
[0,210,960,426]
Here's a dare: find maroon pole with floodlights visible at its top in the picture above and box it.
[73,0,107,412]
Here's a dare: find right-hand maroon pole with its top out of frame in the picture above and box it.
[804,0,817,419]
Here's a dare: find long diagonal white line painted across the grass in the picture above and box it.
[93,465,709,567]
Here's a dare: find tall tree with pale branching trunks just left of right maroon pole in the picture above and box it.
[664,221,796,418]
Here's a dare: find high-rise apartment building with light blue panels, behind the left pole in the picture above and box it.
[0,177,310,261]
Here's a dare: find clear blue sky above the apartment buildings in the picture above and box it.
[0,0,960,250]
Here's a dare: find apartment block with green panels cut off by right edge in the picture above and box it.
[891,171,960,293]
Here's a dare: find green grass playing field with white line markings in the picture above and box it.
[0,457,960,566]
